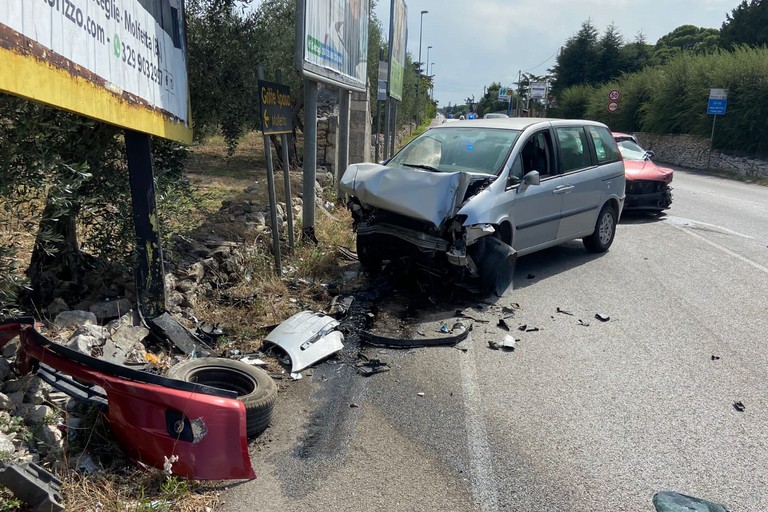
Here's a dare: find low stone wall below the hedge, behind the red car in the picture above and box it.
[634,133,768,177]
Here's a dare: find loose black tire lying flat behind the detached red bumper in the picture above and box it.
[168,357,277,436]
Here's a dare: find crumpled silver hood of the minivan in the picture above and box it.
[339,164,471,227]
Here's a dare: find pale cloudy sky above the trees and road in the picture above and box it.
[369,0,741,107]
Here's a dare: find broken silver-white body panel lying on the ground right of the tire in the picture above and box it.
[264,311,344,374]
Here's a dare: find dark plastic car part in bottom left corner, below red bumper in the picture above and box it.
[0,461,64,512]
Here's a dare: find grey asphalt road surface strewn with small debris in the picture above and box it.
[223,170,768,512]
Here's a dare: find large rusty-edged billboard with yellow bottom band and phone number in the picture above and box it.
[0,0,192,142]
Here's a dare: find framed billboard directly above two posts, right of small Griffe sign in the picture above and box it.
[297,0,370,91]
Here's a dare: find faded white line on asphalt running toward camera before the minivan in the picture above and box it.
[459,340,499,512]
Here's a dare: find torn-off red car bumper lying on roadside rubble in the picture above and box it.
[0,318,256,480]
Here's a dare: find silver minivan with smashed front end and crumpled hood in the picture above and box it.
[340,118,624,295]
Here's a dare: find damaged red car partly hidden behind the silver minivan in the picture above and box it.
[613,132,674,212]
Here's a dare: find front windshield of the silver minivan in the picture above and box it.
[387,127,520,175]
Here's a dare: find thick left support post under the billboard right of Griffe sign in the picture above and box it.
[301,79,317,243]
